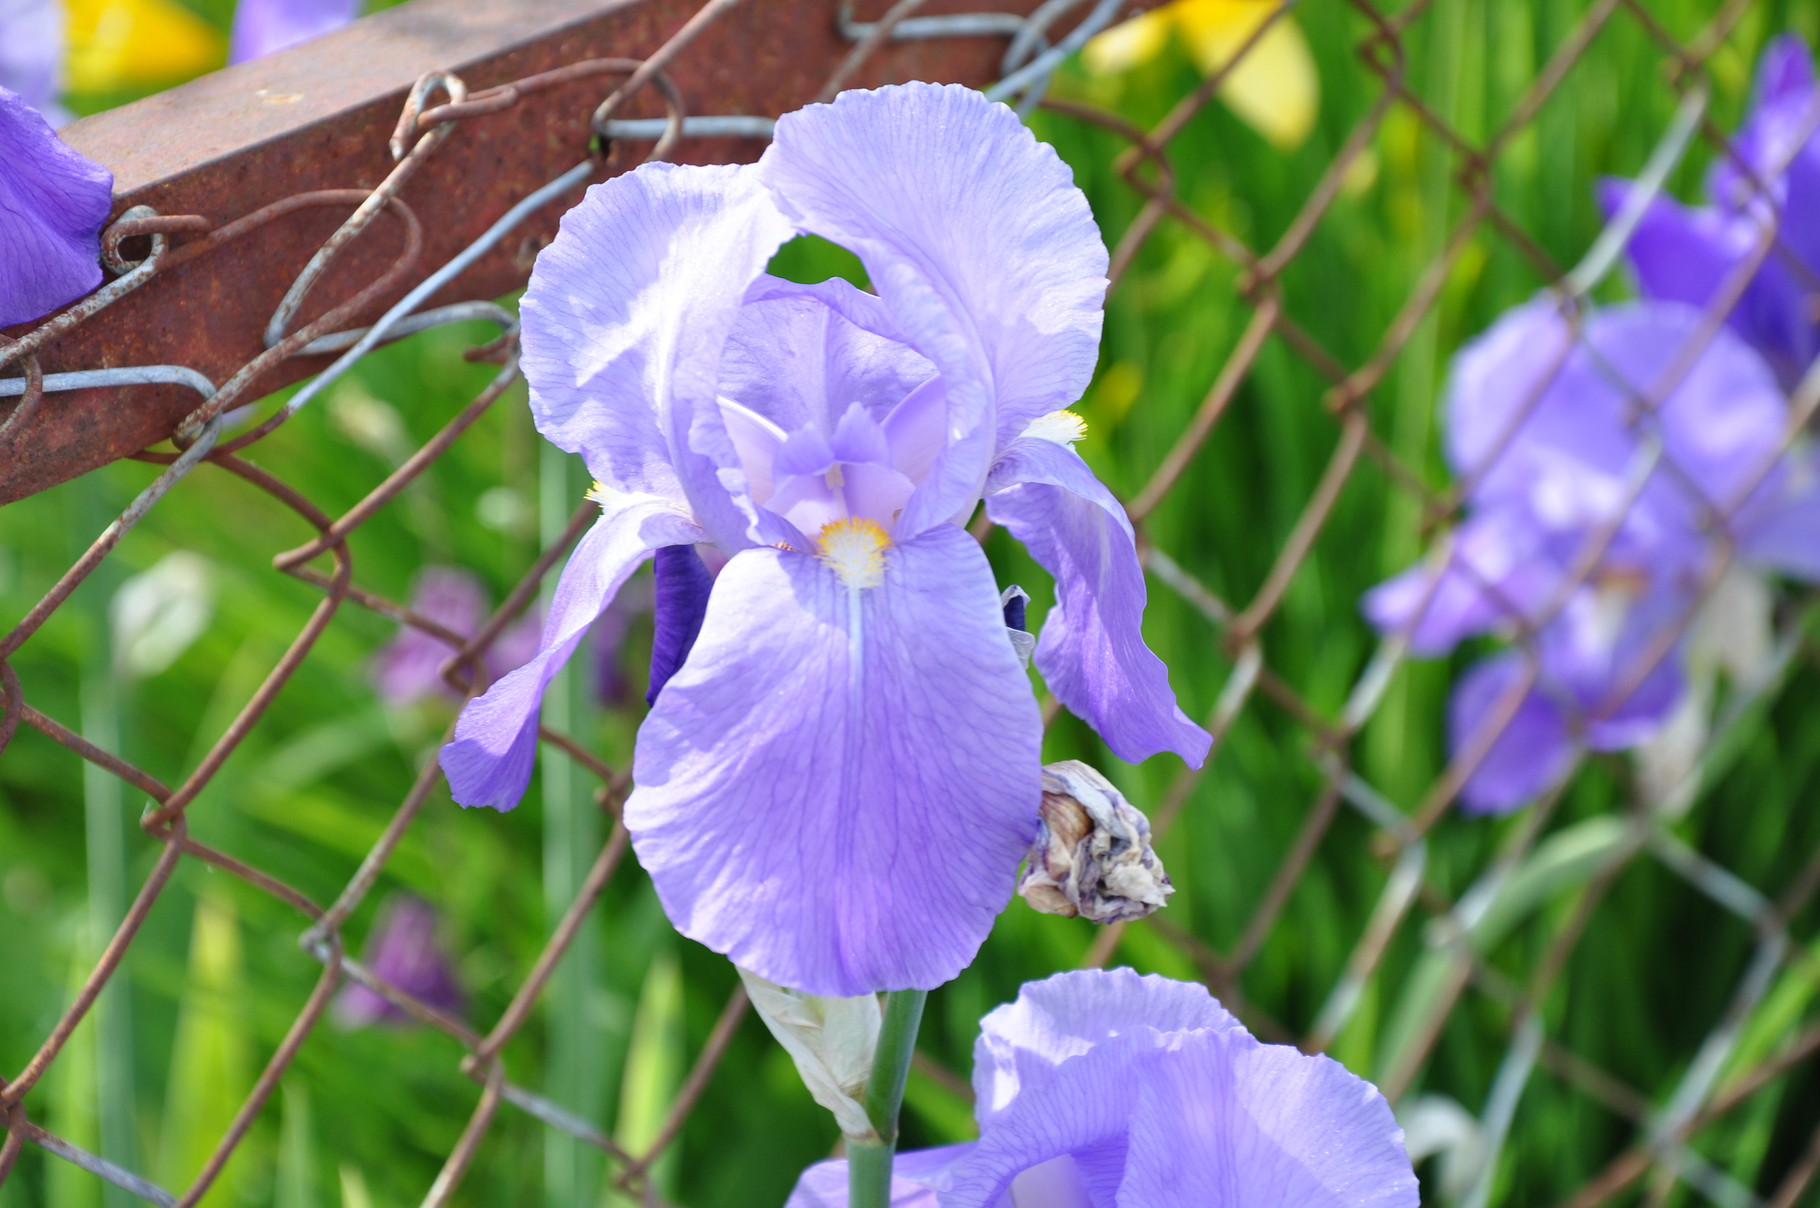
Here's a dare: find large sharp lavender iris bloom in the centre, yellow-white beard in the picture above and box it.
[442,84,1210,995]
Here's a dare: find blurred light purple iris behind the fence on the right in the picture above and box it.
[1365,298,1820,811]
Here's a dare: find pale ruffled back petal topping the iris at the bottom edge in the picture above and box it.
[974,968,1239,1128]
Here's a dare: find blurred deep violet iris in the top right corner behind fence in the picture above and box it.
[1600,35,1820,388]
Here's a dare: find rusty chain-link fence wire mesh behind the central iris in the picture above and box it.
[0,0,1820,1208]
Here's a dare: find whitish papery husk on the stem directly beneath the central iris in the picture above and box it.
[739,970,885,1141]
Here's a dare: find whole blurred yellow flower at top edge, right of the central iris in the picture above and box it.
[1081,0,1321,149]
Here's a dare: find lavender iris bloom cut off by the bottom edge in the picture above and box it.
[786,970,1418,1208]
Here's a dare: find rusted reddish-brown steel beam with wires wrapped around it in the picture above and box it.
[0,0,1099,502]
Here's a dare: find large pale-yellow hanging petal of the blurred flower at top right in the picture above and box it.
[1176,0,1321,149]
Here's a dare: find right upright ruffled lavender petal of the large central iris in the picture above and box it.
[759,84,1107,535]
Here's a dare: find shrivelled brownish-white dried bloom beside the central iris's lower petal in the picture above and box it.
[1017,759,1176,922]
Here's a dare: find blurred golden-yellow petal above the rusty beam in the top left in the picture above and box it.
[66,0,228,93]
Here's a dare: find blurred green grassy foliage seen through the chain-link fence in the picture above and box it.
[10,0,1820,1208]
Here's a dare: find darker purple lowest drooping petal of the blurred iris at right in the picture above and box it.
[1447,653,1576,813]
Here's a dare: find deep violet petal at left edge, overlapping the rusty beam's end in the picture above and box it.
[0,87,113,327]
